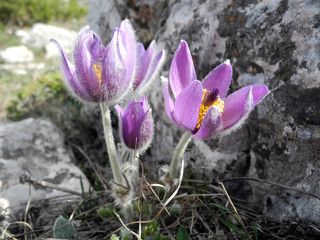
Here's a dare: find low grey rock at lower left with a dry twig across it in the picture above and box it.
[0,118,89,219]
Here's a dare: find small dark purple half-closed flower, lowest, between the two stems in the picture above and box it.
[115,97,154,152]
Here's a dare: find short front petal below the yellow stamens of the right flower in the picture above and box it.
[193,107,222,139]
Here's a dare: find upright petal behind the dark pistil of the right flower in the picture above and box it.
[202,60,232,99]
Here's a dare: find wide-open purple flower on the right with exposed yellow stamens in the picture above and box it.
[164,41,269,139]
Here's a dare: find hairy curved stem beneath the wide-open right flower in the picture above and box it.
[170,132,192,180]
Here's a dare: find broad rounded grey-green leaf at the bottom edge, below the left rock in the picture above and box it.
[53,216,76,239]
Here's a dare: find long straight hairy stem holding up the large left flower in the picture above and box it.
[100,103,126,194]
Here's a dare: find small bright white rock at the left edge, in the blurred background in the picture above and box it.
[0,45,34,63]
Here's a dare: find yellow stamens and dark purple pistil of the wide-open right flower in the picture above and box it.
[195,89,224,131]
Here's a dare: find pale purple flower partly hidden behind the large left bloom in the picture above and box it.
[132,41,165,93]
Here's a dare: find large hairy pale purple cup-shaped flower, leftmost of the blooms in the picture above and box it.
[52,19,136,104]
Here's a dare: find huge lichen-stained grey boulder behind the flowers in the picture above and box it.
[88,0,320,222]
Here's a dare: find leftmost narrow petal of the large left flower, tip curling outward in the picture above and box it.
[50,39,93,101]
